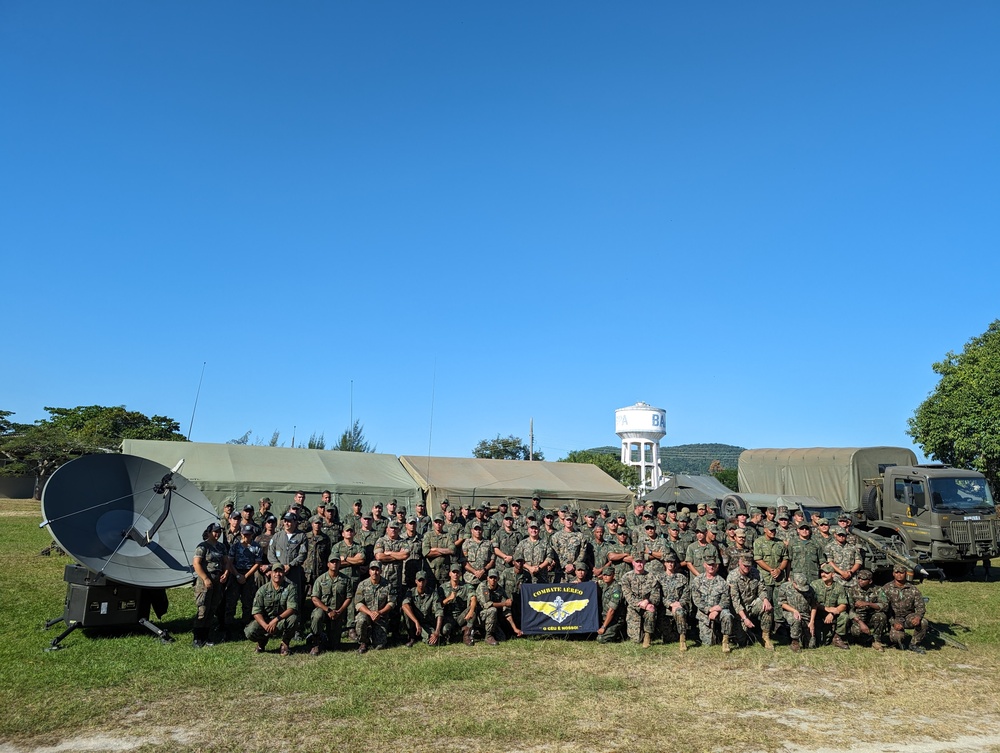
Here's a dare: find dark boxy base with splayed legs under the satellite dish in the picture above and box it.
[45,565,173,651]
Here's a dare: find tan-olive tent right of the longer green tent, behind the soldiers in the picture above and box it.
[400,455,634,513]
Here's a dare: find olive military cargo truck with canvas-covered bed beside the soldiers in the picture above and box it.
[738,447,1000,565]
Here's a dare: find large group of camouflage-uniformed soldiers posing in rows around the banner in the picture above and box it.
[193,492,928,655]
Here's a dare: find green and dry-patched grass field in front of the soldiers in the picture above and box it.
[0,500,1000,753]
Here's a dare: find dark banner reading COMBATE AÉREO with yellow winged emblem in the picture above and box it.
[521,581,601,635]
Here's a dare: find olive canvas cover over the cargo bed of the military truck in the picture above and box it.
[739,447,917,512]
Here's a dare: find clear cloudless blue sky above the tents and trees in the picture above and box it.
[0,0,1000,459]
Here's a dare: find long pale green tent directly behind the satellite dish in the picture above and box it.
[122,439,422,515]
